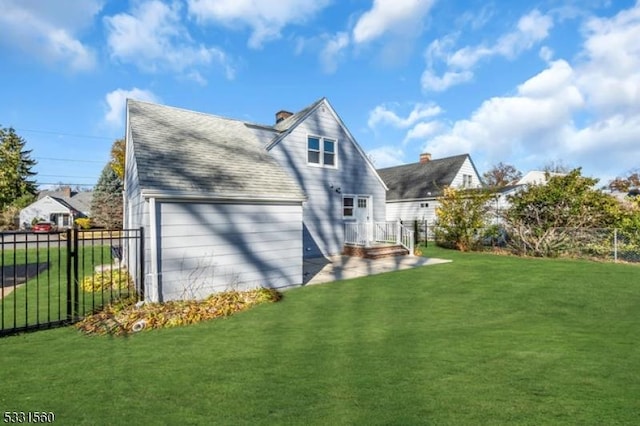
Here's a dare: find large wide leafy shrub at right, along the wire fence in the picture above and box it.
[504,168,621,256]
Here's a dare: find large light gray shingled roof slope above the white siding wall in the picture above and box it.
[127,100,305,200]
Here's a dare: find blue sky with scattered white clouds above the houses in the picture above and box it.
[0,0,640,185]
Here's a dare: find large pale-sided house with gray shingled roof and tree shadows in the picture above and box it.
[124,98,387,301]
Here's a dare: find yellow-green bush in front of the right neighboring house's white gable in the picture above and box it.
[435,187,492,251]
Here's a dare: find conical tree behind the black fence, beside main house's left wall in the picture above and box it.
[91,163,123,228]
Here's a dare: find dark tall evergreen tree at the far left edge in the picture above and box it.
[0,128,37,210]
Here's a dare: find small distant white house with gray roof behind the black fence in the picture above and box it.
[20,187,93,229]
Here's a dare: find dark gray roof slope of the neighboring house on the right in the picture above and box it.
[378,154,469,201]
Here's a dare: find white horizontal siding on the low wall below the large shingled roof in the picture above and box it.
[157,201,302,300]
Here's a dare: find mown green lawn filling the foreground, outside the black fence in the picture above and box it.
[0,248,640,425]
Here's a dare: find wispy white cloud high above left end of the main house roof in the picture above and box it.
[104,0,234,80]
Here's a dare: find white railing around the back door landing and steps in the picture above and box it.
[344,220,414,255]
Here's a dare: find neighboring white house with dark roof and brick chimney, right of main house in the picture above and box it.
[378,153,482,223]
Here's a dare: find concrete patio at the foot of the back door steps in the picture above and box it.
[303,256,451,285]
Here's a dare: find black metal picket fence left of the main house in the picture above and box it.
[0,229,144,336]
